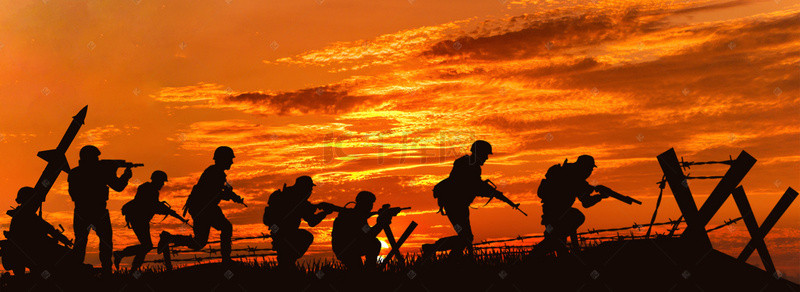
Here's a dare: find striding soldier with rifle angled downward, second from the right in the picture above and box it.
[422,140,519,257]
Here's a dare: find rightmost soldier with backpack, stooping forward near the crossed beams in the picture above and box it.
[533,155,608,256]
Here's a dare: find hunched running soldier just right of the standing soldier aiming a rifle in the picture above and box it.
[114,170,189,271]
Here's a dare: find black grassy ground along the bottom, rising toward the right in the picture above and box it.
[0,239,800,291]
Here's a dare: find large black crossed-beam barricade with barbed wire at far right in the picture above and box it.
[657,148,797,272]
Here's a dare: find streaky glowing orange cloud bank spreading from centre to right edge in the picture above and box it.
[145,1,800,270]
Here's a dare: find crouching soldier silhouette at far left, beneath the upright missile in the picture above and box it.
[1,187,80,275]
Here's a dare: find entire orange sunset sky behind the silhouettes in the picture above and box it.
[0,0,800,281]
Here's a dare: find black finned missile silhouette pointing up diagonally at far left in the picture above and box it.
[31,105,89,217]
